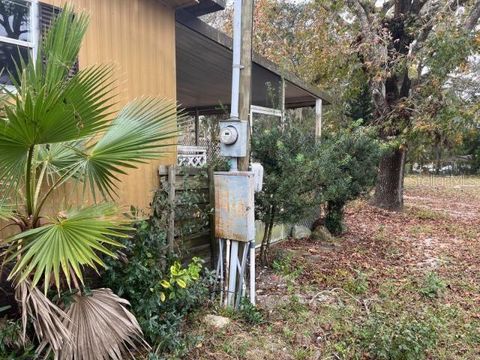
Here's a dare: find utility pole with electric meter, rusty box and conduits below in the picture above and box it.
[214,0,260,308]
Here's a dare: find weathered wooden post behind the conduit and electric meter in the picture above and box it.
[238,0,253,171]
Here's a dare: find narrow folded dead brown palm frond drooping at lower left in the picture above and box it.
[15,281,72,352]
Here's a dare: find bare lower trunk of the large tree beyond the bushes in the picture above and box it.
[373,147,406,211]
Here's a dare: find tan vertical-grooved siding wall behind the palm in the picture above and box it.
[42,0,176,210]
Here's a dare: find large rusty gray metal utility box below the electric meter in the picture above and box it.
[213,171,255,242]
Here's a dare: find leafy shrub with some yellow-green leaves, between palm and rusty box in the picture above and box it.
[102,221,212,359]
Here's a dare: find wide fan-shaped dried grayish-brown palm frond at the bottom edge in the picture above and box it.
[59,289,148,360]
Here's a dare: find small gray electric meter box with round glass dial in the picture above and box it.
[220,120,248,157]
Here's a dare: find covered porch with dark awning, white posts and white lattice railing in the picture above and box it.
[176,10,330,164]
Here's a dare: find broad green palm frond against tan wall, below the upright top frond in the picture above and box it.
[0,66,116,148]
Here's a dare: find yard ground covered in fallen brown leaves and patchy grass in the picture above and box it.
[187,177,480,360]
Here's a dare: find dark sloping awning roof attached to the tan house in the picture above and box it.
[176,11,329,114]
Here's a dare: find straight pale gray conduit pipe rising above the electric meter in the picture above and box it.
[230,0,242,119]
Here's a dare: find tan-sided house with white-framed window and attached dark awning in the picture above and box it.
[0,0,327,209]
